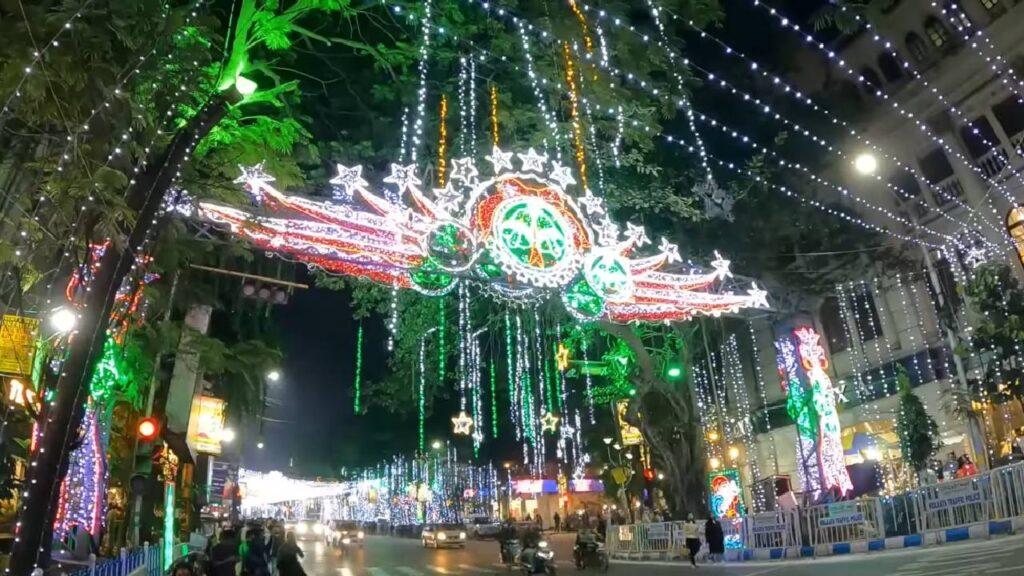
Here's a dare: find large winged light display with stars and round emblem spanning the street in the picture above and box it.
[200,147,767,323]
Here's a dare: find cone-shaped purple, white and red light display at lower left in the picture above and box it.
[53,402,106,538]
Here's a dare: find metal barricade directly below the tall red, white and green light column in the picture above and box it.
[800,498,884,546]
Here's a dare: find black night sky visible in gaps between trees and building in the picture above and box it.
[242,0,827,476]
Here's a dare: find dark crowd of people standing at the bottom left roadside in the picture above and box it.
[171,521,306,576]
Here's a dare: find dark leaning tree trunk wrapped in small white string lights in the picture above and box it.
[10,95,229,576]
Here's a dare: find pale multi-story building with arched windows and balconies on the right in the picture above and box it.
[724,0,1024,502]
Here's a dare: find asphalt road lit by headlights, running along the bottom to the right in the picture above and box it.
[292,534,1024,576]
